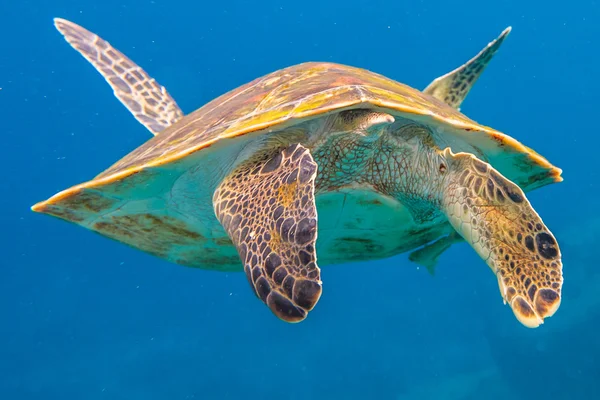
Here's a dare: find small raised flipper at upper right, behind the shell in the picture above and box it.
[423,27,511,109]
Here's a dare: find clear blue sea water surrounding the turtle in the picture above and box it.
[0,0,600,400]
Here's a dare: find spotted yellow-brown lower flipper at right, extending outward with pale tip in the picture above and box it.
[440,149,563,328]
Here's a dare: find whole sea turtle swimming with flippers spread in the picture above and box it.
[32,19,563,327]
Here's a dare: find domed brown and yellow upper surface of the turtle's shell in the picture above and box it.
[97,63,501,178]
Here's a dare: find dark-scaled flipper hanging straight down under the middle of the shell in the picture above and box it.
[213,144,321,322]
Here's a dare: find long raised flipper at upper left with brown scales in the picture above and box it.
[54,18,183,135]
